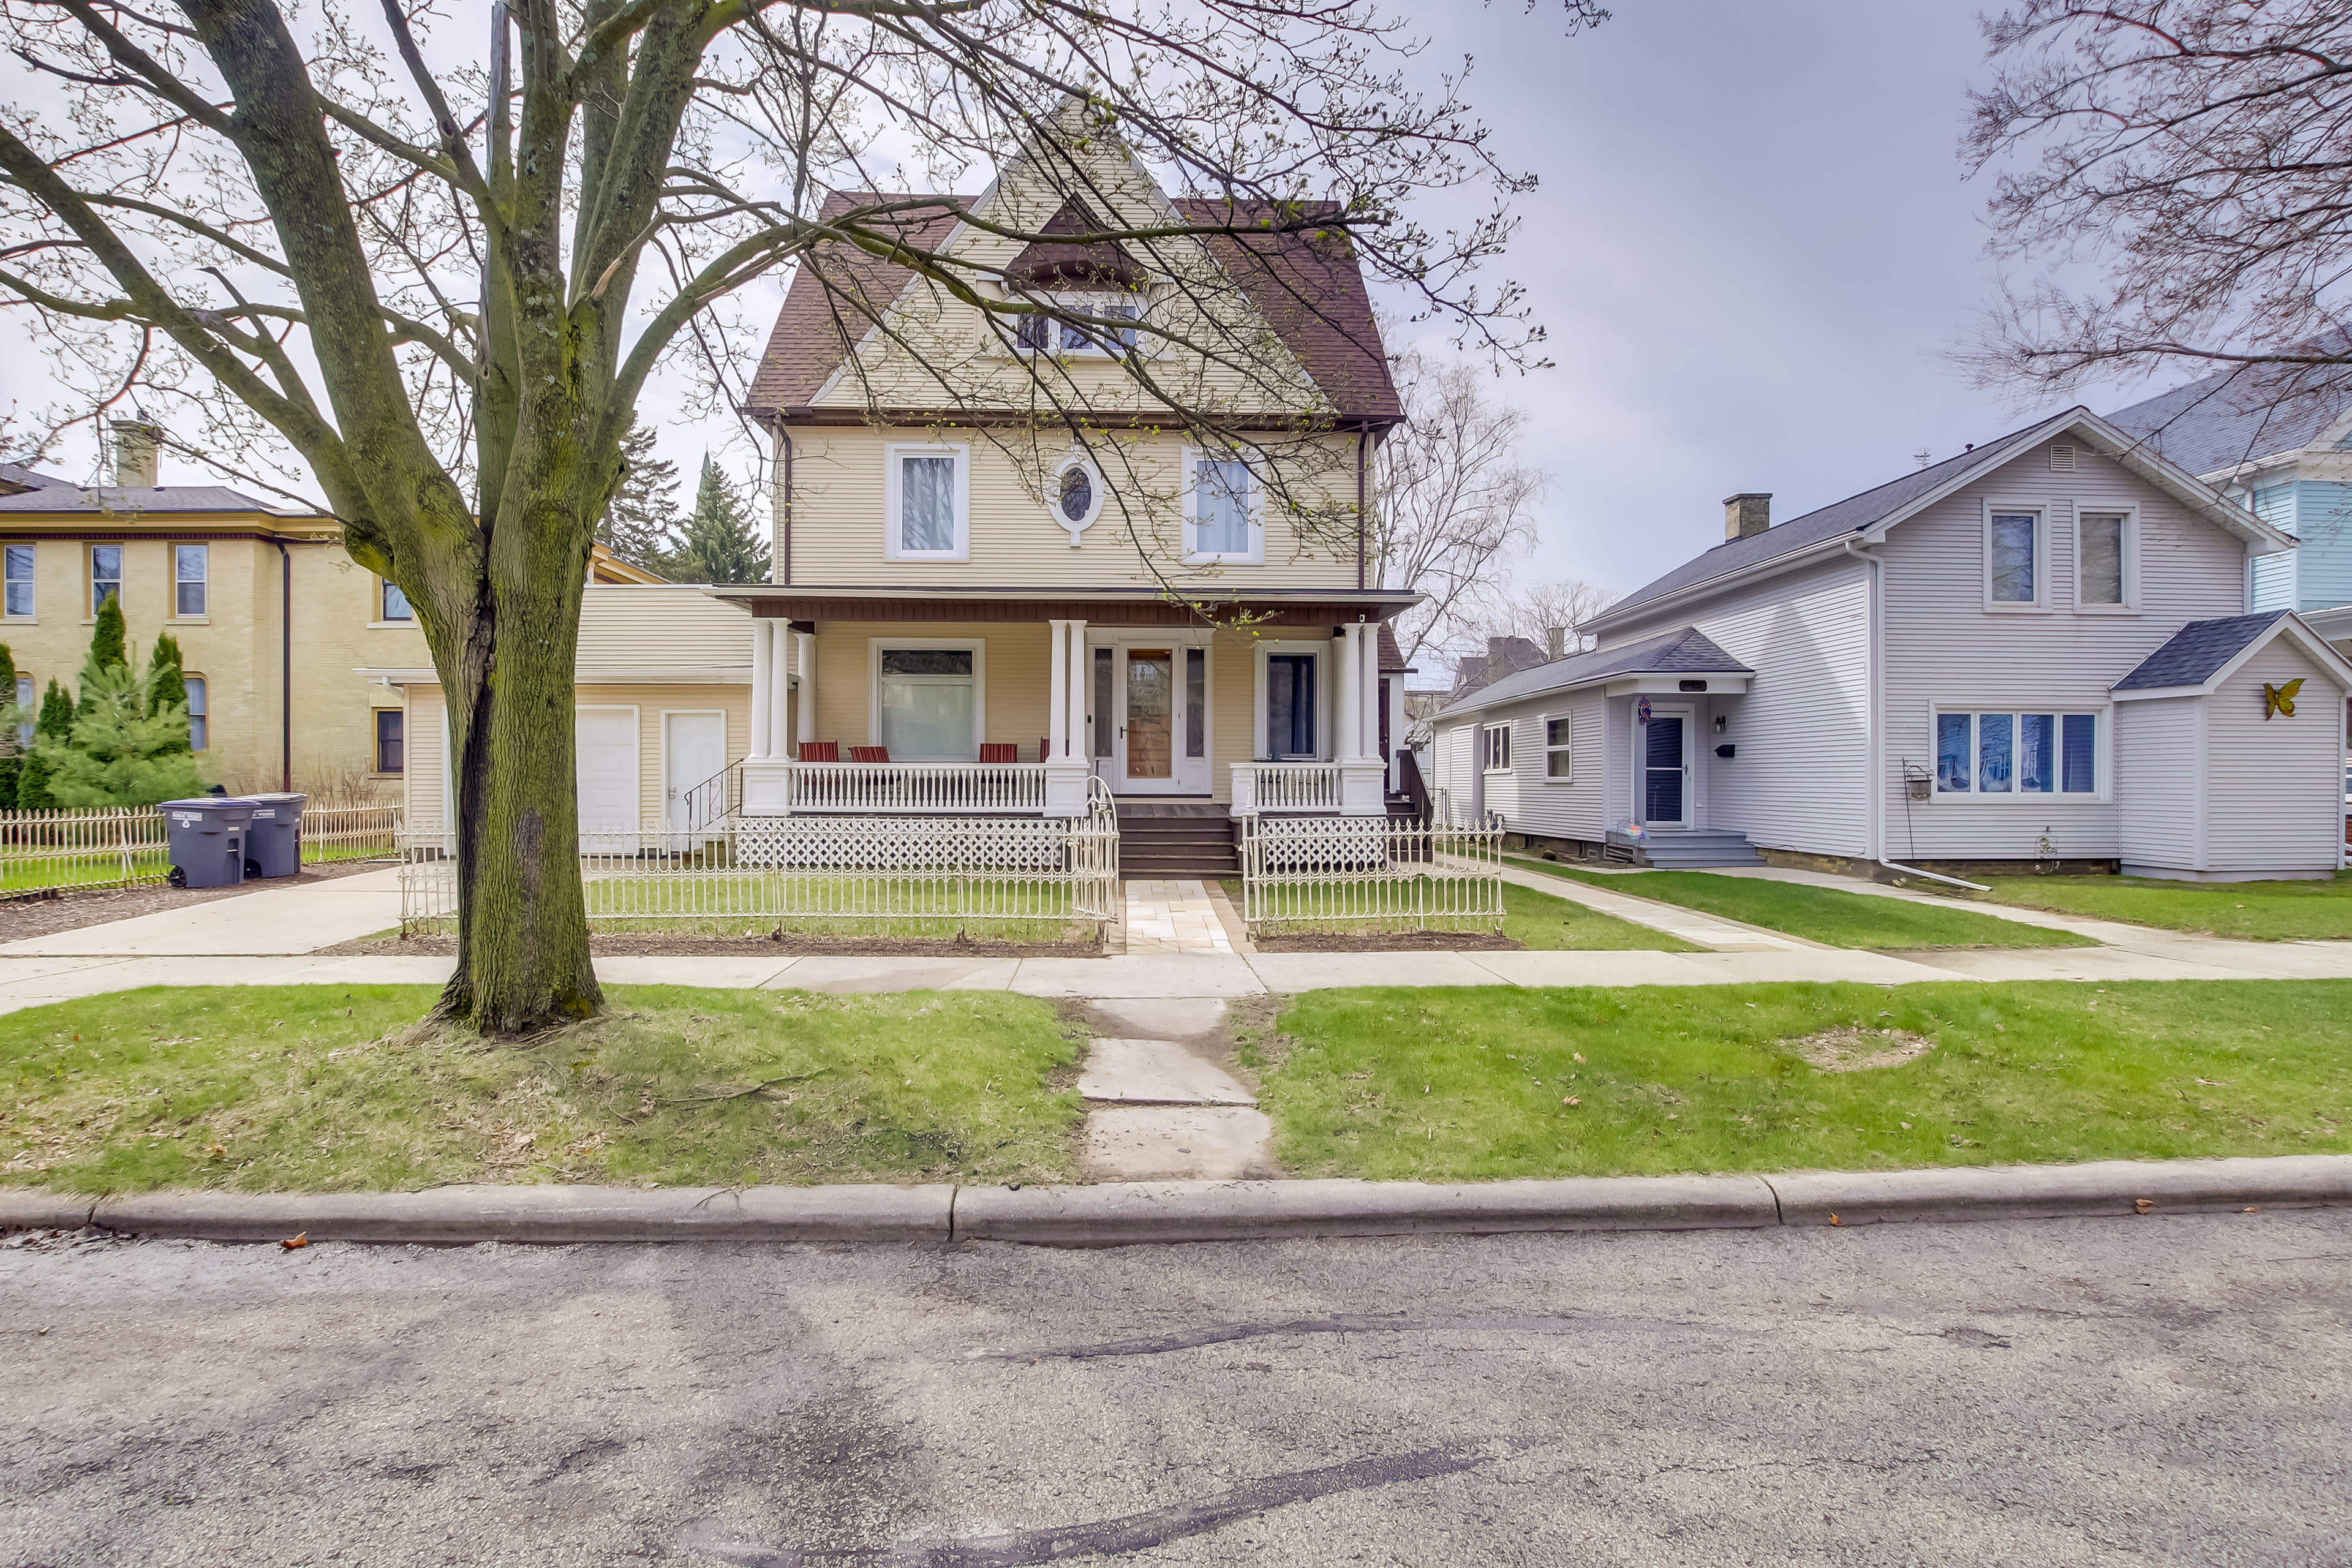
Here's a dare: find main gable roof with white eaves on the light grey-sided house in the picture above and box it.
[1588,407,2296,630]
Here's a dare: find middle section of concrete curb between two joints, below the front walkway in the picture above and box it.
[955,1175,1781,1246]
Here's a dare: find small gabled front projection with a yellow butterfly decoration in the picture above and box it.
[2204,639,2345,872]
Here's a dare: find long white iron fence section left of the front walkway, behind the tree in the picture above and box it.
[400,783,1120,940]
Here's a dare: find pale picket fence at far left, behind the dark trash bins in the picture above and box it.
[0,806,400,898]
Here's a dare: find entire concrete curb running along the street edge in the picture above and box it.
[0,1154,2352,1246]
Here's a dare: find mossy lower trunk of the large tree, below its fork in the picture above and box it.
[435,499,602,1035]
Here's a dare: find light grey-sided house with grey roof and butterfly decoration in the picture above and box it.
[1433,409,2352,881]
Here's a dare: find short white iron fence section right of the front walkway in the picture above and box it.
[1242,816,1503,936]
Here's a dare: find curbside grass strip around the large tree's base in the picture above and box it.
[0,985,1082,1192]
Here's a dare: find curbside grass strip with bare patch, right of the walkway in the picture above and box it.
[1244,980,2352,1180]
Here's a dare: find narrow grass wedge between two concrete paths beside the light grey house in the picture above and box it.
[1506,856,2095,952]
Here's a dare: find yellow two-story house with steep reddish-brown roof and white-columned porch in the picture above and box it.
[708,123,1416,870]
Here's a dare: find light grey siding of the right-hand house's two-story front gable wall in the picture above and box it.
[1863,447,2246,861]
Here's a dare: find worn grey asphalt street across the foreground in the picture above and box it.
[0,1211,2352,1568]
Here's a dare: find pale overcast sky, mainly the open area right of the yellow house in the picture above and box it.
[0,0,2163,620]
